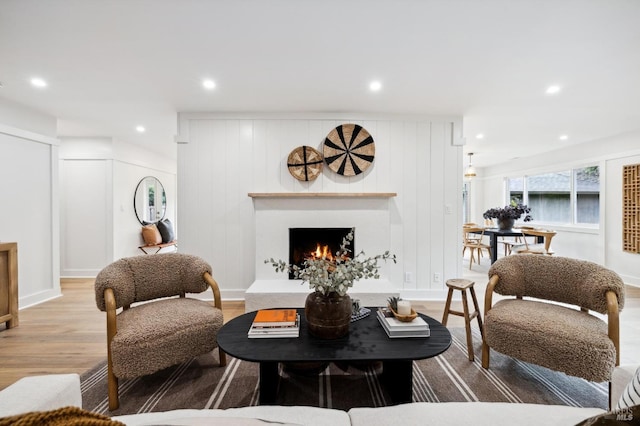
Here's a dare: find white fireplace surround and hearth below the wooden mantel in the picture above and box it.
[245,197,399,311]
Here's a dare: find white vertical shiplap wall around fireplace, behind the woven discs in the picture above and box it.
[178,113,462,298]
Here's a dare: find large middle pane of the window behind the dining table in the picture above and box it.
[527,171,572,223]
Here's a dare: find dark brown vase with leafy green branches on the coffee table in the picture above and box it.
[265,229,396,339]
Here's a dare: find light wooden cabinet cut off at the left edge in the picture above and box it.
[0,243,18,328]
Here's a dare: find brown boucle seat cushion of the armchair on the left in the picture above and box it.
[111,298,223,379]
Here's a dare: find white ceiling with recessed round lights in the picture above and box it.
[0,0,640,167]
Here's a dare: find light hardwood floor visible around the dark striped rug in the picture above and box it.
[0,274,640,389]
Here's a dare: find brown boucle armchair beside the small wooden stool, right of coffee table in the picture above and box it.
[482,255,624,382]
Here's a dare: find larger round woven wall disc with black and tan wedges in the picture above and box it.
[322,124,376,176]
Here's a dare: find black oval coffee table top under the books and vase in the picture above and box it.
[218,308,451,362]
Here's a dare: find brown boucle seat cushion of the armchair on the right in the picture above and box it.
[485,299,616,382]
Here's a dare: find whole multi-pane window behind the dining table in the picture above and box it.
[507,166,600,224]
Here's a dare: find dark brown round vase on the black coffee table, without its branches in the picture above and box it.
[304,291,351,339]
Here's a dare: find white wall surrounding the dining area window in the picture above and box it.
[480,132,640,285]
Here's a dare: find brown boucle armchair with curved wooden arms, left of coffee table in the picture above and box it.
[95,253,226,410]
